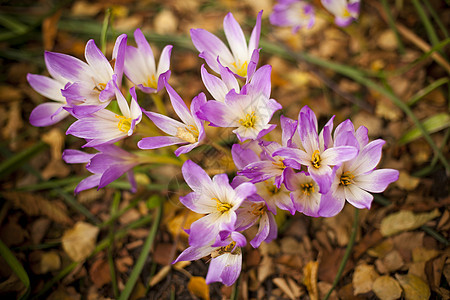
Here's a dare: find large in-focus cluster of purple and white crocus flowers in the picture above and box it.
[28,9,398,285]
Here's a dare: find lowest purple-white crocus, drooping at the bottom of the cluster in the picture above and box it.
[172,231,247,286]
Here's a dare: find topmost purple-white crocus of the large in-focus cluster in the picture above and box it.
[191,11,262,78]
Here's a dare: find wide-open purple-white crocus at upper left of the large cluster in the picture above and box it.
[45,34,127,117]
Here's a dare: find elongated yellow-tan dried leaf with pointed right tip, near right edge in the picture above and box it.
[380,209,440,236]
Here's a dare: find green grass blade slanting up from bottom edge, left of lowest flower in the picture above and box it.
[119,201,163,300]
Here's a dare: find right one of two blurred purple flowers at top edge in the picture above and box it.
[321,0,360,27]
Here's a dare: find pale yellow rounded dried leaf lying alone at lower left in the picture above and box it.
[61,222,100,261]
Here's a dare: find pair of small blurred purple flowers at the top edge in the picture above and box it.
[270,0,360,33]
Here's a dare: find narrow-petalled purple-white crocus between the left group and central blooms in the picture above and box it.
[138,82,206,156]
